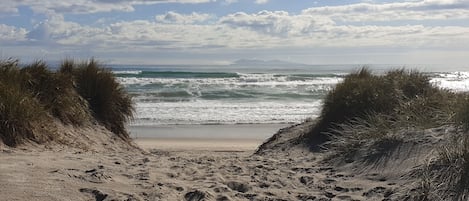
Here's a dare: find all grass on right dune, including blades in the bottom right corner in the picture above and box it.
[307,68,469,200]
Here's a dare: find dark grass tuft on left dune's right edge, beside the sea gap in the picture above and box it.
[59,59,134,139]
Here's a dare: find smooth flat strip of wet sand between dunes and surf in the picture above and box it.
[128,124,290,152]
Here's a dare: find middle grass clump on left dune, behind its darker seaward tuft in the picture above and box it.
[21,61,90,125]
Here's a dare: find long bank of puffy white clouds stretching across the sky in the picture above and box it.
[11,11,469,51]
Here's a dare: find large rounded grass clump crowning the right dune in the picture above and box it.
[308,68,454,148]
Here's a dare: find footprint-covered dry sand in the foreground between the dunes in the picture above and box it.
[0,141,370,200]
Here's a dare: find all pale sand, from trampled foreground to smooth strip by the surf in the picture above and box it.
[0,122,450,201]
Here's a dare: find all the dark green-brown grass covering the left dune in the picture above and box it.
[0,59,133,146]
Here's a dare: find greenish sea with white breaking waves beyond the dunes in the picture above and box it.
[111,65,469,126]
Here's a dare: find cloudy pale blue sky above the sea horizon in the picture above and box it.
[0,0,469,65]
